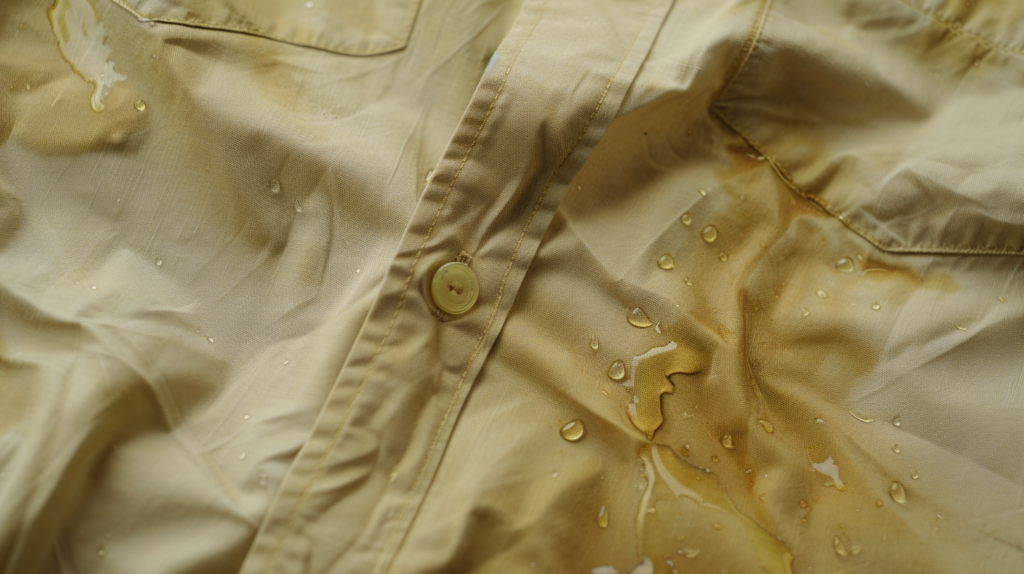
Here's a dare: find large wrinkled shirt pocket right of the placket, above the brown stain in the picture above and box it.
[714,0,1024,255]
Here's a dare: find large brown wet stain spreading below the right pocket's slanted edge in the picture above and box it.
[644,127,961,571]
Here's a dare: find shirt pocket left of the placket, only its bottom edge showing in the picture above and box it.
[114,0,420,56]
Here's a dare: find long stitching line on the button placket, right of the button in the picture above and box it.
[374,2,653,573]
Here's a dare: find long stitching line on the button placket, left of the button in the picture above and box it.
[256,18,540,572]
